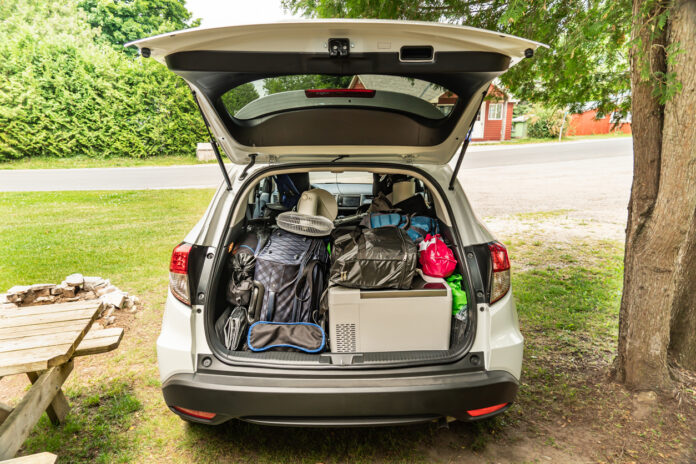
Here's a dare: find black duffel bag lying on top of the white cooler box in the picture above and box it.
[329,227,418,290]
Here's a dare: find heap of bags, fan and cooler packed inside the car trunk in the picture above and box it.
[215,173,466,354]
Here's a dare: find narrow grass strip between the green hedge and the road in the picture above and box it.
[0,155,217,169]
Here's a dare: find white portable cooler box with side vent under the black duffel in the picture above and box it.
[329,270,452,353]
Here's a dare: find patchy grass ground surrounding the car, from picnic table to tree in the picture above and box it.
[0,190,696,463]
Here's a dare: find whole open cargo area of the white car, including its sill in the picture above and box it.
[206,167,476,368]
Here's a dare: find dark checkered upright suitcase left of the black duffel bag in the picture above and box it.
[254,229,329,322]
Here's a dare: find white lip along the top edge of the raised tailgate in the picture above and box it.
[125,19,544,62]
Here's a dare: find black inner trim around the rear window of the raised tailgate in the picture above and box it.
[165,50,510,154]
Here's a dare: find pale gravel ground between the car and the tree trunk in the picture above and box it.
[460,156,633,240]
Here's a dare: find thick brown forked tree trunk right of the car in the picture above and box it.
[616,0,696,390]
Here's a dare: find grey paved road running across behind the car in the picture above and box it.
[0,138,631,192]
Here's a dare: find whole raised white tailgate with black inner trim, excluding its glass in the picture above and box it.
[128,20,542,165]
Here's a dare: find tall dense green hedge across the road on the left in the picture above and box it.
[0,0,204,161]
